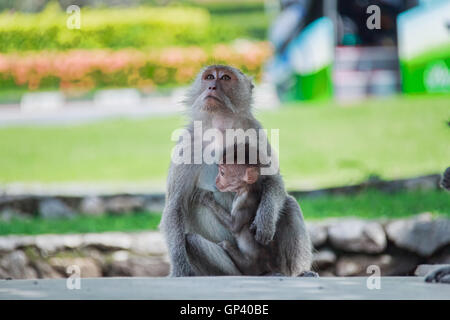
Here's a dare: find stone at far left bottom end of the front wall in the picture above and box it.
[0,250,37,279]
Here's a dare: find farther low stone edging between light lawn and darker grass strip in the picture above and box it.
[0,174,440,220]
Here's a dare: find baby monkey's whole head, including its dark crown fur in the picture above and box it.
[216,144,259,192]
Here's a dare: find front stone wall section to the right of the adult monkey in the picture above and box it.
[308,213,450,276]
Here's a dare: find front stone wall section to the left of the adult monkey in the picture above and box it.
[0,232,169,279]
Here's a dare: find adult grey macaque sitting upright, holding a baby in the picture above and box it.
[161,65,312,277]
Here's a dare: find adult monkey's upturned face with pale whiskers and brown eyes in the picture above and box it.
[191,66,253,113]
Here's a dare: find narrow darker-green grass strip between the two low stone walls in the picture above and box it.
[0,191,450,235]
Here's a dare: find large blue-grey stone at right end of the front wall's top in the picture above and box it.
[386,213,450,257]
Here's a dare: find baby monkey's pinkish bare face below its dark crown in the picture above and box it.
[216,164,259,192]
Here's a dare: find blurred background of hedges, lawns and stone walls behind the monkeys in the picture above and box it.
[0,0,450,278]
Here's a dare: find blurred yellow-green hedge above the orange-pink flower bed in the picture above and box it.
[0,3,267,52]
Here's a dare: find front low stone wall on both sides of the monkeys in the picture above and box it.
[0,213,450,279]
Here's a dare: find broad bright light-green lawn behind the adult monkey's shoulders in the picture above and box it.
[0,96,450,189]
